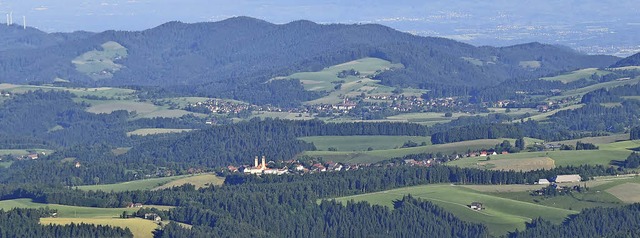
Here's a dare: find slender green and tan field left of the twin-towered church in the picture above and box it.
[77,174,224,192]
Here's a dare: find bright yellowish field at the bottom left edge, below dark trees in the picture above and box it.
[40,218,159,238]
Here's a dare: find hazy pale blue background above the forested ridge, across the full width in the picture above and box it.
[0,0,640,54]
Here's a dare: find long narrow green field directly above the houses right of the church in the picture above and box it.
[302,139,515,163]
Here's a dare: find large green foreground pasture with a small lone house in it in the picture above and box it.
[336,184,577,236]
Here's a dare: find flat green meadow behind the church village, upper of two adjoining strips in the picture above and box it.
[299,136,431,151]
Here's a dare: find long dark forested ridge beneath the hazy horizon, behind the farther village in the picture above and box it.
[0,17,618,104]
